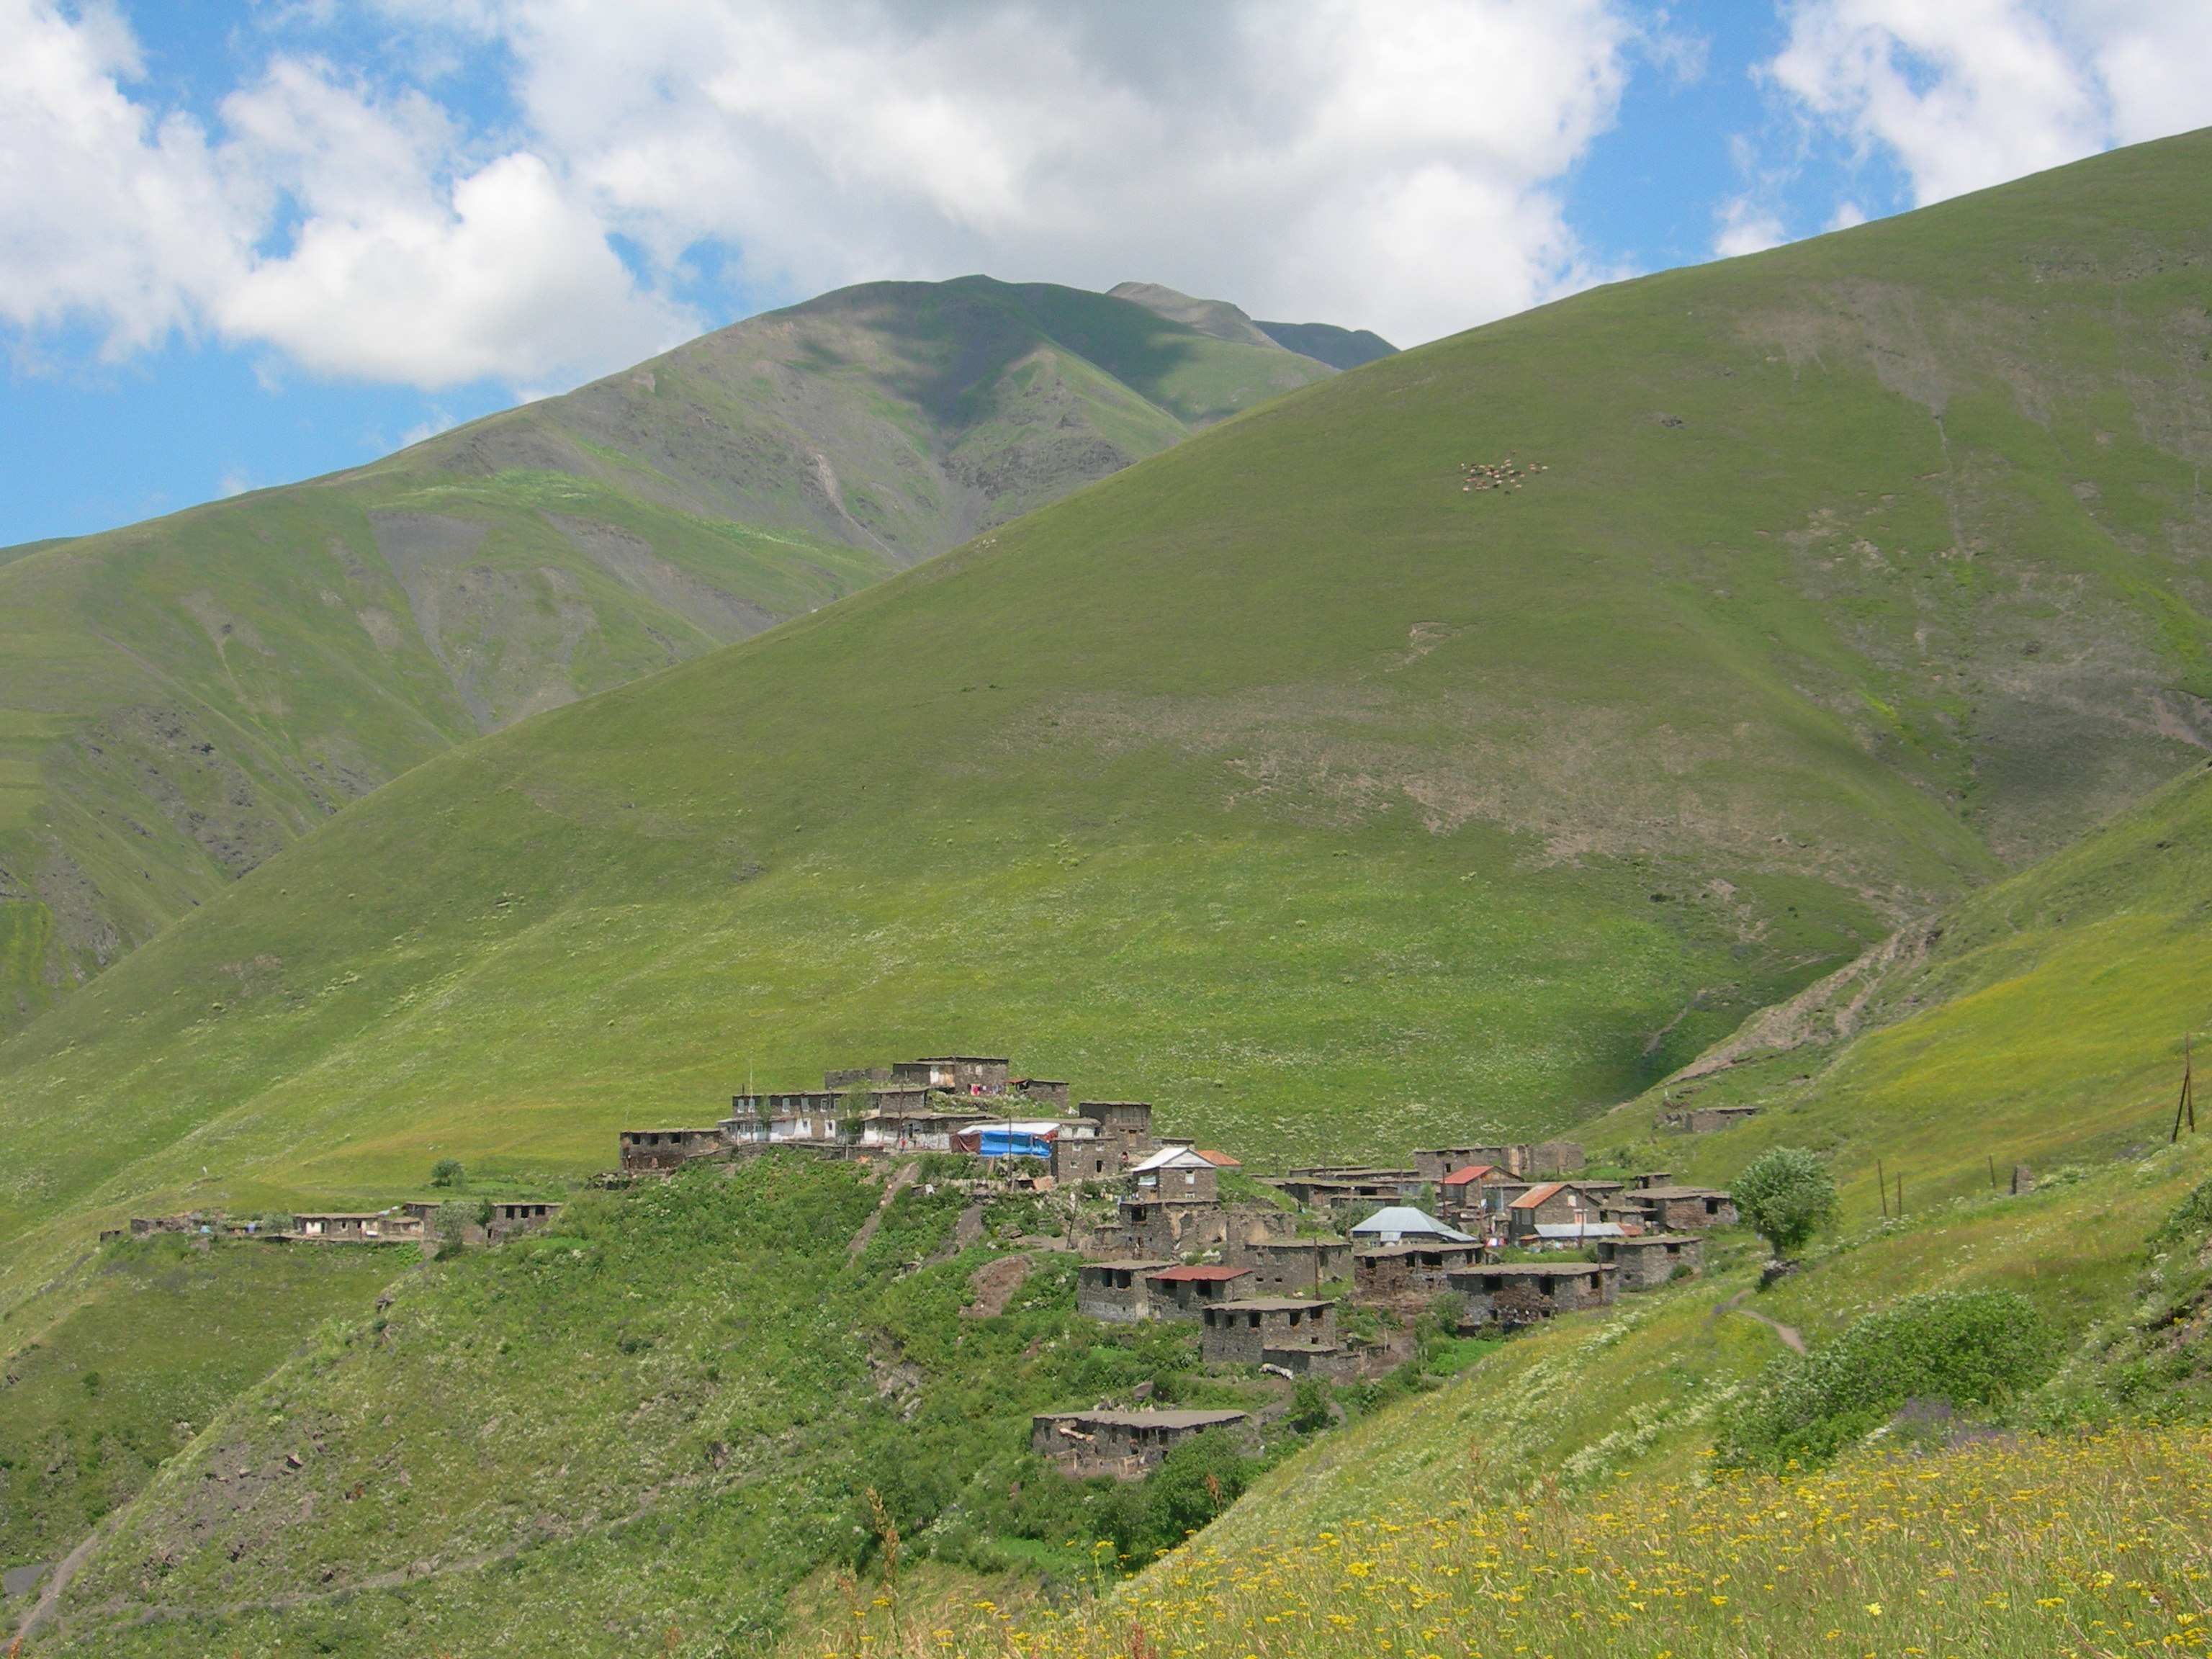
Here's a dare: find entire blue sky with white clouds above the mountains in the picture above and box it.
[0,0,2212,544]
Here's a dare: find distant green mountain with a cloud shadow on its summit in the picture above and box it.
[0,276,1329,1028]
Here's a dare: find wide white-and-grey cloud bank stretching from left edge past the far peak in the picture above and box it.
[0,0,1635,387]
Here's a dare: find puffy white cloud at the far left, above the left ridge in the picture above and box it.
[0,0,690,387]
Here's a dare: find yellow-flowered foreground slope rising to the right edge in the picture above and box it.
[942,770,2212,1655]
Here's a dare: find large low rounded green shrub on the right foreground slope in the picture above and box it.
[1719,1290,2057,1471]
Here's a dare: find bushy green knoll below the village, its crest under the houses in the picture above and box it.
[26,1155,1283,1655]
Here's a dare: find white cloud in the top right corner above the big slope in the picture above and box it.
[1768,0,2212,204]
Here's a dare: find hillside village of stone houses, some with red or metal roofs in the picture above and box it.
[106,1055,1737,1478]
